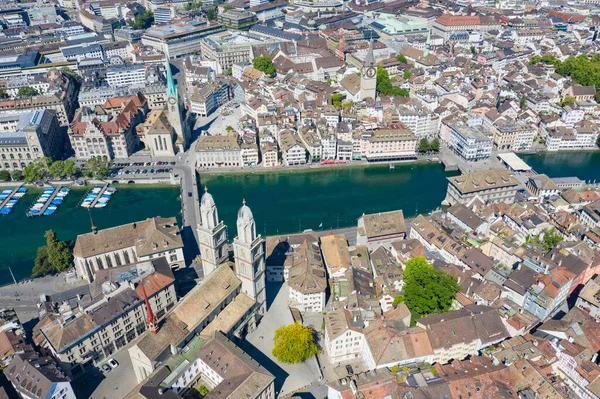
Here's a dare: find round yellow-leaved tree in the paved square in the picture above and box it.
[272,323,319,364]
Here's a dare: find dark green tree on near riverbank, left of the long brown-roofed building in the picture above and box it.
[31,230,73,277]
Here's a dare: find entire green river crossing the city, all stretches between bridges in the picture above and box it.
[0,152,600,285]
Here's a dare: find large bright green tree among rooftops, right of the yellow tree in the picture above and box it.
[403,257,460,317]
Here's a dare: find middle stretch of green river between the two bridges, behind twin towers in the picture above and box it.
[200,164,456,237]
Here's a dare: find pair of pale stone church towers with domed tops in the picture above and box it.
[197,188,267,316]
